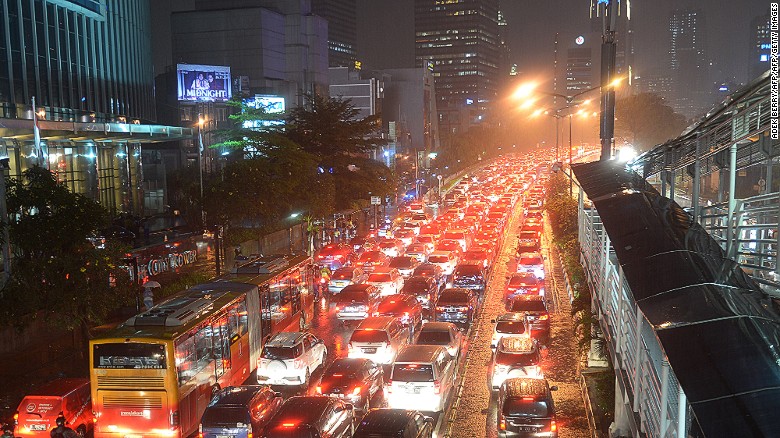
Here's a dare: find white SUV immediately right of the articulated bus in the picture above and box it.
[257,332,328,386]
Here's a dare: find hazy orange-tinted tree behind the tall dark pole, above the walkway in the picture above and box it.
[615,93,686,150]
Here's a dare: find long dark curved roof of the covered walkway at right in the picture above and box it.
[572,162,780,437]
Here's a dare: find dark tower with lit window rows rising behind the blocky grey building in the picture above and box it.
[311,0,357,68]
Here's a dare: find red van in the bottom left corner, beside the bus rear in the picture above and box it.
[14,378,94,438]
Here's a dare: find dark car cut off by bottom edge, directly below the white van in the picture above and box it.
[352,408,433,438]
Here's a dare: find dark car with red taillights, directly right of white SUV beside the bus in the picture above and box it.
[317,357,384,413]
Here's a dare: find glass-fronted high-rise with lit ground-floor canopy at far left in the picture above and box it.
[0,0,192,216]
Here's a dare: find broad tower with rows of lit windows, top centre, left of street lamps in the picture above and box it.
[414,0,500,142]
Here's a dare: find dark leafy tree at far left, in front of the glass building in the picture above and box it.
[0,166,136,340]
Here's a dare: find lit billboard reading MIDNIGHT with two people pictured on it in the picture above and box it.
[176,64,232,102]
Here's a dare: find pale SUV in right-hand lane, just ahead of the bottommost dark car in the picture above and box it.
[489,338,544,390]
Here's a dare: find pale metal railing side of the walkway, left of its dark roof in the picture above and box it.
[579,204,688,438]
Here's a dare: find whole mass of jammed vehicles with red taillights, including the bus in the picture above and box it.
[12,156,565,438]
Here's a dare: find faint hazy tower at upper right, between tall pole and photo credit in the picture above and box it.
[669,9,710,117]
